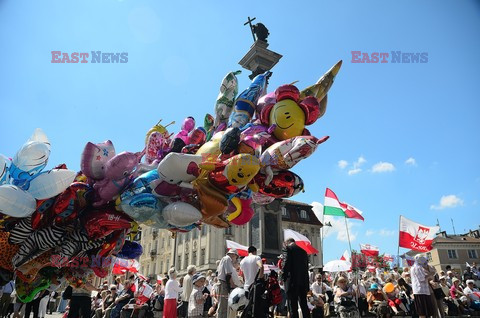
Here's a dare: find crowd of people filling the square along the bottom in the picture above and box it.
[0,239,480,318]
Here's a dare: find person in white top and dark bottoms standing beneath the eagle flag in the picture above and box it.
[411,255,435,318]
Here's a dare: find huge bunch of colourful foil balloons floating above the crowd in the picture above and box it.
[0,61,341,301]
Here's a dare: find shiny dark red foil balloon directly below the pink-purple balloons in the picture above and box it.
[81,208,133,239]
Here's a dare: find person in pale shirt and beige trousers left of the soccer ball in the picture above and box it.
[217,248,242,318]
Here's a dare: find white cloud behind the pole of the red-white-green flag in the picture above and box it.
[311,202,358,242]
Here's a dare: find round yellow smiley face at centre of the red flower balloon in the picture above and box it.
[270,99,305,140]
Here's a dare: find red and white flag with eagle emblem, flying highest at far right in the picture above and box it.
[398,216,440,252]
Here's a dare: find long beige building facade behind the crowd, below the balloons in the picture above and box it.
[140,200,322,276]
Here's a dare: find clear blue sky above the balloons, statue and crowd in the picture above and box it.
[0,0,480,260]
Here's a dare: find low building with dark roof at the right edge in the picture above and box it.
[407,230,480,273]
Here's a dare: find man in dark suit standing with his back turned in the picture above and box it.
[282,238,310,318]
